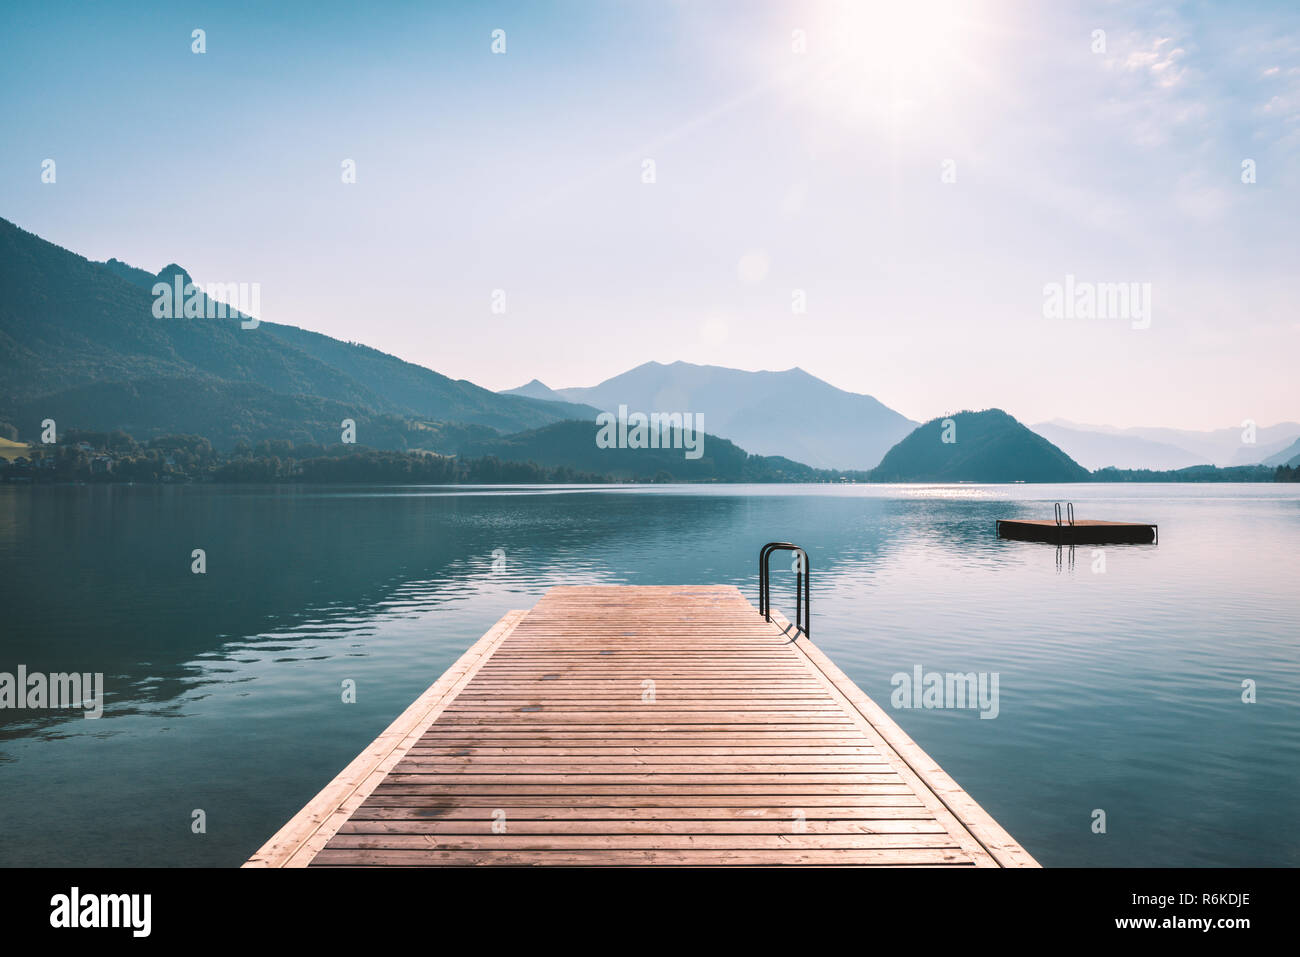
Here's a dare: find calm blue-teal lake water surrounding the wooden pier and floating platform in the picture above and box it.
[0,485,1300,866]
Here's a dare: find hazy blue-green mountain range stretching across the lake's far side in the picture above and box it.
[0,220,1300,481]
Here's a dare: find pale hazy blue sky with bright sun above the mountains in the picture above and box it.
[0,0,1300,428]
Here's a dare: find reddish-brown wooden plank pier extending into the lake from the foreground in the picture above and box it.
[244,586,1036,867]
